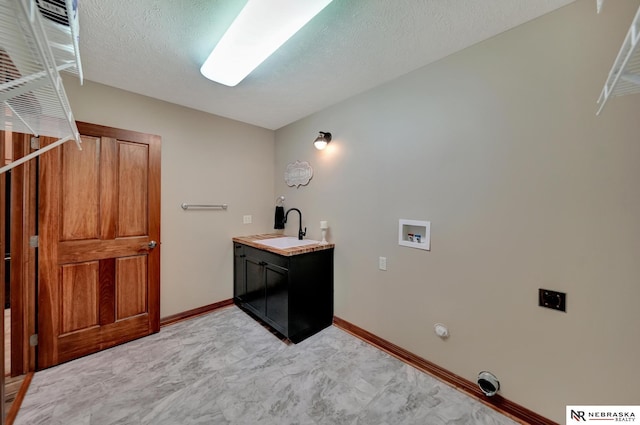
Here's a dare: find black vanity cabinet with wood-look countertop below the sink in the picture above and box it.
[233,235,334,343]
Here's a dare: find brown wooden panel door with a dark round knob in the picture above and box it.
[38,123,160,368]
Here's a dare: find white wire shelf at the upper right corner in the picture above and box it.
[596,3,640,115]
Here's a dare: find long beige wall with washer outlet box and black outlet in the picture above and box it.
[275,0,640,423]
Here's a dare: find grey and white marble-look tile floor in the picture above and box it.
[14,306,516,425]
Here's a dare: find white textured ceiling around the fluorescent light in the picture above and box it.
[79,0,576,129]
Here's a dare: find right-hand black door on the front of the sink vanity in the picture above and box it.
[264,263,289,335]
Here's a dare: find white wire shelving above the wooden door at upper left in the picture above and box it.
[0,0,82,173]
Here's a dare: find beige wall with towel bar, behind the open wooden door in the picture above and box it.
[65,78,274,317]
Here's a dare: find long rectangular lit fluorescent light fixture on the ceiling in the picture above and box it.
[200,0,332,87]
